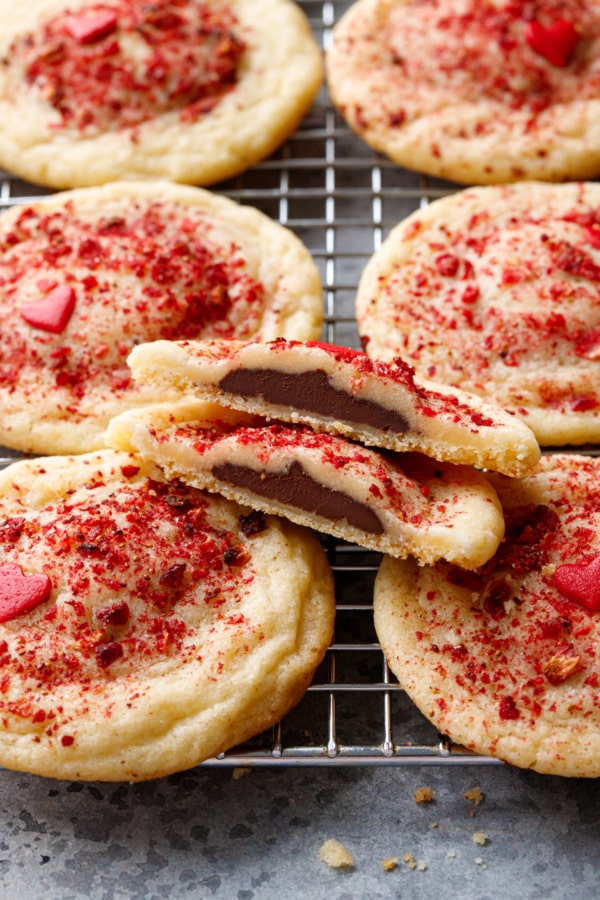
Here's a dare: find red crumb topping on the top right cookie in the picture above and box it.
[347,0,600,134]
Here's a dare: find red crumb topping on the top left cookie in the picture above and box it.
[9,0,245,136]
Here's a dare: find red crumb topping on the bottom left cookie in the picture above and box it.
[0,467,254,736]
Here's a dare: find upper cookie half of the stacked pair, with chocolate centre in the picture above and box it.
[128,338,540,476]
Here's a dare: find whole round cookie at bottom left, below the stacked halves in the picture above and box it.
[0,450,335,781]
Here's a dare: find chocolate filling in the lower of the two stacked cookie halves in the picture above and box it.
[213,462,384,534]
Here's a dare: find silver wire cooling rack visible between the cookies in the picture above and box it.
[0,0,497,766]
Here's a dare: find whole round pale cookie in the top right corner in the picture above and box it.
[327,0,600,184]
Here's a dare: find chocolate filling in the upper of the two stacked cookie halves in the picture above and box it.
[219,369,408,434]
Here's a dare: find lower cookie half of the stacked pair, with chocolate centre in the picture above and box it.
[107,399,504,568]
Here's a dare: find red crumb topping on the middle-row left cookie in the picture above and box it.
[0,201,266,416]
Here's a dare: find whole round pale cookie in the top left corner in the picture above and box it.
[0,0,323,188]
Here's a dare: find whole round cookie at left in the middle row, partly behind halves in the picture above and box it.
[0,182,323,454]
